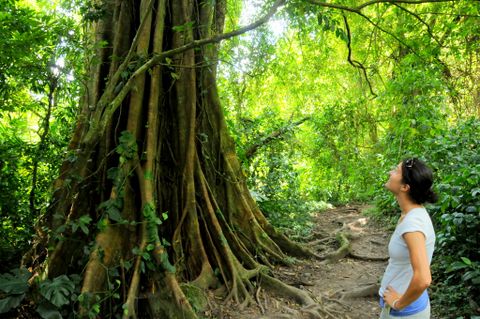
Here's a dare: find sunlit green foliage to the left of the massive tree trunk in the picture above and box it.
[0,0,82,271]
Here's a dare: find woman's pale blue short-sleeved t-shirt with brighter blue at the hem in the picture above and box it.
[378,207,435,316]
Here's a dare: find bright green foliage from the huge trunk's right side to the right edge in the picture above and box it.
[219,3,480,316]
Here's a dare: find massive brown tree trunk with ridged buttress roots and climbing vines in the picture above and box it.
[24,0,313,318]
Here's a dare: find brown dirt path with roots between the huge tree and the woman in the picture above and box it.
[204,207,390,319]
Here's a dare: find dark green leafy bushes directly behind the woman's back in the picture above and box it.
[424,119,480,316]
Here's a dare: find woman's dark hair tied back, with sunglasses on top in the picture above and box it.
[402,158,438,204]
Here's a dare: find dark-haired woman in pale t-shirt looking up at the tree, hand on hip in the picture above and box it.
[379,158,437,319]
